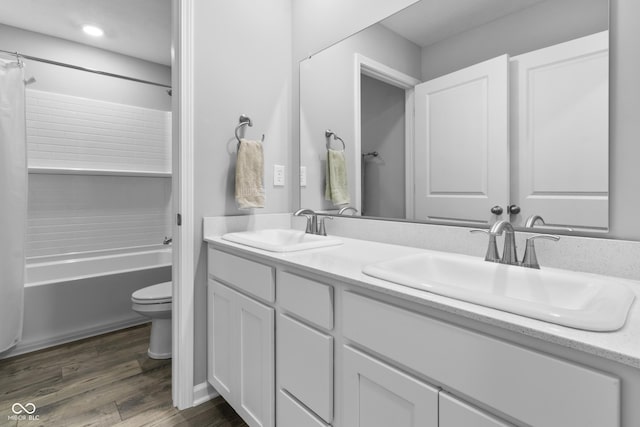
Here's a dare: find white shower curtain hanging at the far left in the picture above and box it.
[0,58,27,352]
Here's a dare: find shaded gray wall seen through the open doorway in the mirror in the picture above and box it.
[360,75,405,219]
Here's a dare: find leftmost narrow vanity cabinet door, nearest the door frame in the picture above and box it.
[207,280,237,401]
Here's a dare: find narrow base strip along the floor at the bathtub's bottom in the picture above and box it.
[0,316,149,359]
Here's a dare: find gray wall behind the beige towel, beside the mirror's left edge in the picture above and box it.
[192,0,292,384]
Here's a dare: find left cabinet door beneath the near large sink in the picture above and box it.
[343,346,438,427]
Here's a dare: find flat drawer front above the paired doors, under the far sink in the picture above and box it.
[208,249,275,302]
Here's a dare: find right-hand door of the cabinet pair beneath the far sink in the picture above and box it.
[231,291,275,427]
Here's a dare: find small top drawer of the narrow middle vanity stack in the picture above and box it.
[278,271,333,330]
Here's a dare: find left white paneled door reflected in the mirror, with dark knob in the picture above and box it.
[414,55,509,224]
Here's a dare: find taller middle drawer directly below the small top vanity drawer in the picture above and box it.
[276,315,333,423]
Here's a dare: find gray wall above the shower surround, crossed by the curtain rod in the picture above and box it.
[0,24,171,111]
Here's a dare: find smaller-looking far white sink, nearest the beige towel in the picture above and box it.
[222,229,342,252]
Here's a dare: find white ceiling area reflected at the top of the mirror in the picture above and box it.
[381,0,543,47]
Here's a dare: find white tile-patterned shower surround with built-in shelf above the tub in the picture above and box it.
[26,90,171,257]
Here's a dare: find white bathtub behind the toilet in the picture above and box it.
[0,246,171,358]
